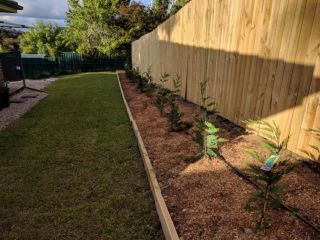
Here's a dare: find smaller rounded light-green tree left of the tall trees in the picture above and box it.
[20,21,68,57]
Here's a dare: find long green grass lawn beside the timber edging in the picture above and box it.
[0,73,162,240]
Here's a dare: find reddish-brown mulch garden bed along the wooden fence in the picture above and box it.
[120,74,320,240]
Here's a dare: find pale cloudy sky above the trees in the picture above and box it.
[0,0,152,27]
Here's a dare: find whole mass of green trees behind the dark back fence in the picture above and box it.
[17,0,189,57]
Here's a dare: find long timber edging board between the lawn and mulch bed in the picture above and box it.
[116,70,179,240]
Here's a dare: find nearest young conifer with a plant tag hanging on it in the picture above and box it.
[244,120,293,231]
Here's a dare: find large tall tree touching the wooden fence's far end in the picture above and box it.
[64,0,159,57]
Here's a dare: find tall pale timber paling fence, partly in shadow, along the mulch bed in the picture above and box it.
[132,0,320,158]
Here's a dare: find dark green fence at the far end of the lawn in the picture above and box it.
[22,52,125,78]
